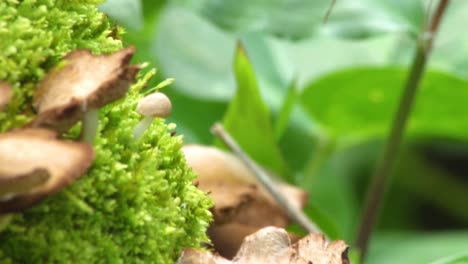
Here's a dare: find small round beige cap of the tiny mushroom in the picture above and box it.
[137,92,172,118]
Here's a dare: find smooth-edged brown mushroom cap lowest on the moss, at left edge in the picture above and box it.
[0,129,94,214]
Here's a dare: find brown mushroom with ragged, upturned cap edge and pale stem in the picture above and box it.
[29,47,139,143]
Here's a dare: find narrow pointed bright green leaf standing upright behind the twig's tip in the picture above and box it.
[223,44,284,175]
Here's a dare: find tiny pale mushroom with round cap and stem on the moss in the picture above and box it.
[133,92,172,140]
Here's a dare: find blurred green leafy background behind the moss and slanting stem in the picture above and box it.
[101,0,468,263]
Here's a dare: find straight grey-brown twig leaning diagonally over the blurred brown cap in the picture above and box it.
[211,123,322,233]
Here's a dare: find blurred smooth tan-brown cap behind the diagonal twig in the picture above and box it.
[182,145,307,258]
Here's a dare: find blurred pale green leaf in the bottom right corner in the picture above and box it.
[366,231,468,264]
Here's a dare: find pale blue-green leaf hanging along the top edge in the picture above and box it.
[178,0,424,40]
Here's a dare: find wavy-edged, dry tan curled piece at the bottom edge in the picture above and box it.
[178,227,349,264]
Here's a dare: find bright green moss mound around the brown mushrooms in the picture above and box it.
[0,0,211,263]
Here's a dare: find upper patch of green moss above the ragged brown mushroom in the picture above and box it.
[0,0,122,131]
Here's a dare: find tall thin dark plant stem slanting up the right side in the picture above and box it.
[355,0,449,260]
